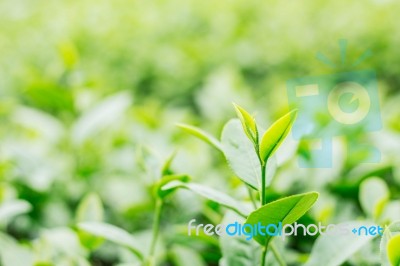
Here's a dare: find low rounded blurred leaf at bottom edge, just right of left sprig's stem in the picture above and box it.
[171,245,207,266]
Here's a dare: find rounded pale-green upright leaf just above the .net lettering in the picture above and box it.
[359,177,390,219]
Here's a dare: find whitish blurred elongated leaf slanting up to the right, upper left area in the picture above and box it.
[72,92,132,144]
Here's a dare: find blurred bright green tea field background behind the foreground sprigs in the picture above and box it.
[0,0,400,266]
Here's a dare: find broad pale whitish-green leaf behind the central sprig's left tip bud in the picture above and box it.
[221,119,261,189]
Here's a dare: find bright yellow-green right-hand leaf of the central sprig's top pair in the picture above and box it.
[260,110,297,162]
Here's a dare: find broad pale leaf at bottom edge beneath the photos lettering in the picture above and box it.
[305,221,375,266]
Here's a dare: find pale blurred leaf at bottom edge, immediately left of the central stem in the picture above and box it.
[219,211,261,266]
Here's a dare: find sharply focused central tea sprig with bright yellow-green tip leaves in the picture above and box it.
[173,104,318,266]
